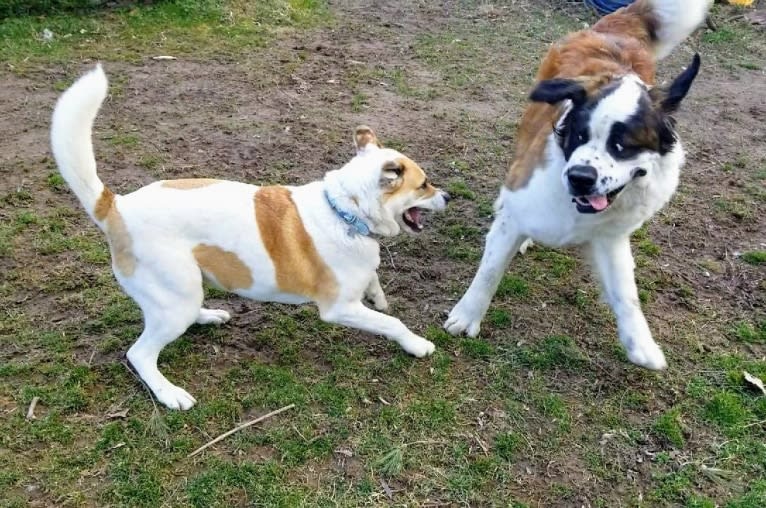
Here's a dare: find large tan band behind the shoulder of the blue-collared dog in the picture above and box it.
[254,186,338,303]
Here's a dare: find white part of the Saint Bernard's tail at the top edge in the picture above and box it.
[648,0,713,59]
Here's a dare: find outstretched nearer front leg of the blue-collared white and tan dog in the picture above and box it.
[319,302,436,358]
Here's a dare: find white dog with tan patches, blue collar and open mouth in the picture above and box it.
[51,66,449,409]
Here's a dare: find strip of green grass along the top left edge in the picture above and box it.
[0,0,327,71]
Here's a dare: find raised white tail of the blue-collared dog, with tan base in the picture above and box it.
[51,65,114,229]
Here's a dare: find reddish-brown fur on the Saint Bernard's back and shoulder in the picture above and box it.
[505,0,657,190]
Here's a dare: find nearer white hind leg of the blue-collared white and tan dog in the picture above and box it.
[120,259,207,409]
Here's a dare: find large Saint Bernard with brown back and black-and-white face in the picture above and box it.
[444,0,713,369]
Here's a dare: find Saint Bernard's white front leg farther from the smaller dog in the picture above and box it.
[590,236,667,370]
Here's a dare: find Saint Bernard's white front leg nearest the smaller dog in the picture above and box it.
[444,209,526,337]
